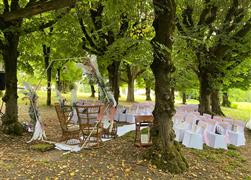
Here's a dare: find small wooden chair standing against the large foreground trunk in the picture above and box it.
[134,115,153,147]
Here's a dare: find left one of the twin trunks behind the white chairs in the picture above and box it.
[199,74,212,115]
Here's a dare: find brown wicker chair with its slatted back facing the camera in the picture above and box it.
[76,105,103,147]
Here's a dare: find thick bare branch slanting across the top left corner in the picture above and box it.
[0,0,76,22]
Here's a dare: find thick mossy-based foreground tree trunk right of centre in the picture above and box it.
[145,0,188,173]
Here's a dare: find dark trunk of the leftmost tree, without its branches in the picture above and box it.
[2,31,23,135]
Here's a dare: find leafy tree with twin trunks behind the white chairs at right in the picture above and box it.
[177,0,251,115]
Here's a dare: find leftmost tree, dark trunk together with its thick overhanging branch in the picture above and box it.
[0,0,75,134]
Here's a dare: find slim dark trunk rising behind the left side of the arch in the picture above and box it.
[43,45,52,106]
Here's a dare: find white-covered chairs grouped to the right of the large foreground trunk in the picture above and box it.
[173,113,245,149]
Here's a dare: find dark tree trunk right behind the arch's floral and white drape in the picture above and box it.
[107,61,120,103]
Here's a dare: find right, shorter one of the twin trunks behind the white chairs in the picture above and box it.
[211,90,225,116]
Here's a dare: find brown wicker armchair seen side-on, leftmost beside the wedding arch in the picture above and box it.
[55,103,81,141]
